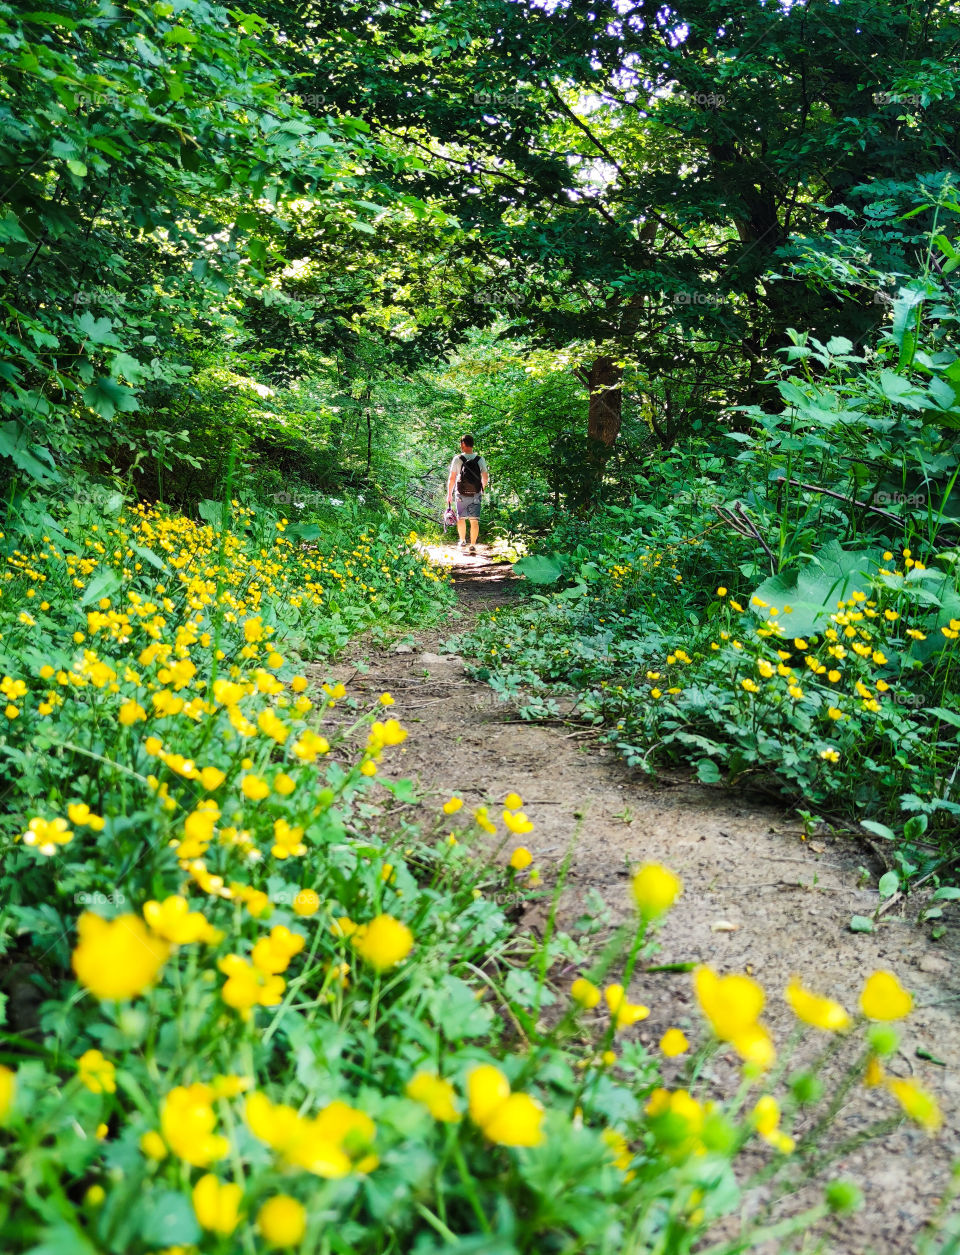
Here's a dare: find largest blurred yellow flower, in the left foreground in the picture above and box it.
[73,911,169,1000]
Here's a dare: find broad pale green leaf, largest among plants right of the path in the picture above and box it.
[750,541,881,636]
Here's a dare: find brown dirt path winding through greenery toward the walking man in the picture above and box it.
[336,556,960,1255]
